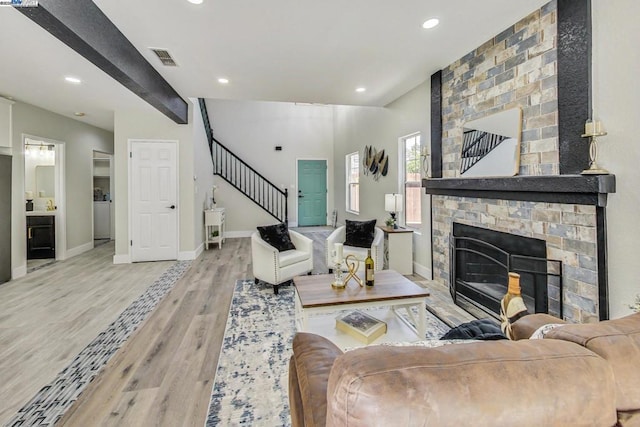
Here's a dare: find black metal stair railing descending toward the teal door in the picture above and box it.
[198,98,289,223]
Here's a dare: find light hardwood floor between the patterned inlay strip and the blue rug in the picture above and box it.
[60,238,252,426]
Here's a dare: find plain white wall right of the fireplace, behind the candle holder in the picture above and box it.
[591,0,640,318]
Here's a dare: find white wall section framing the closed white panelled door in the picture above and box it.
[114,105,197,263]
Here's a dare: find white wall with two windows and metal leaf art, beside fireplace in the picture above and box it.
[334,81,431,277]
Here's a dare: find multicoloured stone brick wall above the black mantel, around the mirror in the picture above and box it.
[442,0,559,178]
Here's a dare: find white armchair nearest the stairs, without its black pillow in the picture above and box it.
[251,230,313,294]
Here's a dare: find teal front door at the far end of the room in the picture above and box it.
[297,160,327,226]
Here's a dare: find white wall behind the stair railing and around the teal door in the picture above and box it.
[207,99,334,232]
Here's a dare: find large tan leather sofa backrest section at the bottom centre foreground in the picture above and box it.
[327,340,616,427]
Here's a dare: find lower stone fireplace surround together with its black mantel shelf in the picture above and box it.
[424,175,615,323]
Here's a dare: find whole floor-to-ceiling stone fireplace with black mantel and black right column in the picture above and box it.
[423,0,615,322]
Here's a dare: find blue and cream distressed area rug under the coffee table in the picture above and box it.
[206,280,449,427]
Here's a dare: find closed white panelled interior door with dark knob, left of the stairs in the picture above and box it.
[129,141,178,262]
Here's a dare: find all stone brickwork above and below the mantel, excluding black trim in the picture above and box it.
[432,0,599,323]
